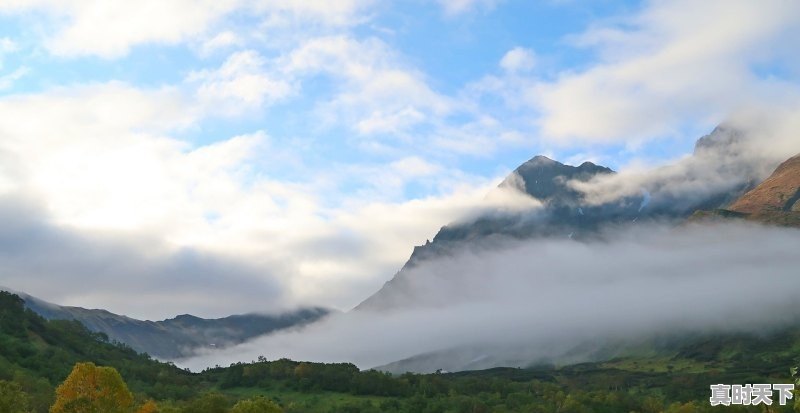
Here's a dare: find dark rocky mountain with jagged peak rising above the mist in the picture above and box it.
[355,126,763,311]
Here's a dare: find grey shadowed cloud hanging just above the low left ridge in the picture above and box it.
[0,195,284,319]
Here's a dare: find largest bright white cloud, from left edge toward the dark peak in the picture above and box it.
[0,82,520,317]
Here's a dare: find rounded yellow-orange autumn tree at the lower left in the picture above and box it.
[50,363,133,413]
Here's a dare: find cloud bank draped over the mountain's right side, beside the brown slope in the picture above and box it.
[570,110,800,212]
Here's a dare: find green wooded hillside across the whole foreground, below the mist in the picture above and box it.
[0,293,800,413]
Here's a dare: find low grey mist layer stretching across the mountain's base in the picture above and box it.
[178,223,800,371]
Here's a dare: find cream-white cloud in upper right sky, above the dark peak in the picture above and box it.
[528,0,800,144]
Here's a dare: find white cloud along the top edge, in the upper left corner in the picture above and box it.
[0,0,372,58]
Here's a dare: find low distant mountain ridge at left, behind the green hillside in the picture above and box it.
[3,288,330,360]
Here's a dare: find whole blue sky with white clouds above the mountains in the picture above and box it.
[0,0,800,319]
